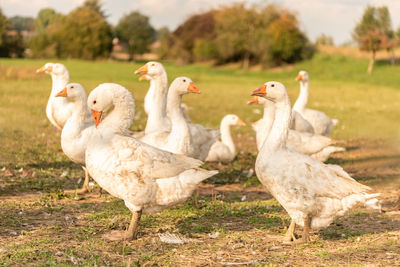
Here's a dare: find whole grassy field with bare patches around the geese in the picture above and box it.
[0,53,400,266]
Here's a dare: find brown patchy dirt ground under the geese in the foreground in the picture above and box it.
[0,140,400,266]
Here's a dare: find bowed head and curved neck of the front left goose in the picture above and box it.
[87,83,135,127]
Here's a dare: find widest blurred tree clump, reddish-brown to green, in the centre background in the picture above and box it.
[156,3,313,68]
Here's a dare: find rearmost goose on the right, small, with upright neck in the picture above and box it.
[293,70,338,136]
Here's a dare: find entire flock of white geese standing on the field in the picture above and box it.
[37,62,380,242]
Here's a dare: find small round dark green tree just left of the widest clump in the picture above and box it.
[115,11,156,60]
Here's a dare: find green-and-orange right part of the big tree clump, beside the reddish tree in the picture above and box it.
[215,4,312,68]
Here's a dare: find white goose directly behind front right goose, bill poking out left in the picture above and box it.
[248,96,345,162]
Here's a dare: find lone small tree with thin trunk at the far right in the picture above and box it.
[353,6,394,74]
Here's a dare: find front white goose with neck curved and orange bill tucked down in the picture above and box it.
[86,83,217,240]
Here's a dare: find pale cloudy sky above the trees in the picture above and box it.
[0,0,400,44]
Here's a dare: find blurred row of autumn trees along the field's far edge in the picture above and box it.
[0,0,400,73]
